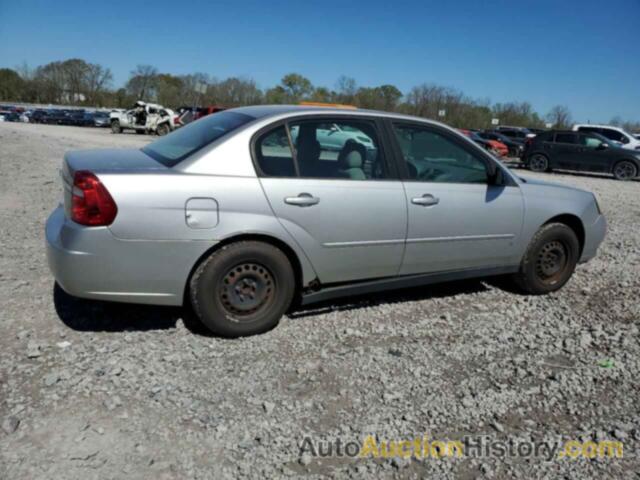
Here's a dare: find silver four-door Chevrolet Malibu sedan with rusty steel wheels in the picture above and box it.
[46,106,606,336]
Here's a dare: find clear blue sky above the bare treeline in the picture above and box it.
[0,0,640,122]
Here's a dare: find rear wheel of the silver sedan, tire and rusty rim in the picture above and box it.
[189,241,295,337]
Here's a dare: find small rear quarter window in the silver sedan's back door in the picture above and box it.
[255,125,296,177]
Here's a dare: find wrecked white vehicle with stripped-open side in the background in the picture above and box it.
[109,101,177,135]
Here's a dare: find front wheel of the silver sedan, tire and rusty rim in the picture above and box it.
[513,223,580,295]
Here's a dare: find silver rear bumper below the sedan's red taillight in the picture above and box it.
[45,207,215,305]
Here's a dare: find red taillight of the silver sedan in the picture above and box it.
[71,170,118,227]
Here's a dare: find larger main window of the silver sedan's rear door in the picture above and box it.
[289,119,387,180]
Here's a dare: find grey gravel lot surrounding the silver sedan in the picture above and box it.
[0,123,640,480]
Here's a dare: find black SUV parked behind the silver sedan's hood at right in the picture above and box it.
[523,130,640,180]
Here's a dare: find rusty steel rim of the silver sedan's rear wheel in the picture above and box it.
[218,262,276,321]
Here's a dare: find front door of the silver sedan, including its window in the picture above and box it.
[389,123,524,274]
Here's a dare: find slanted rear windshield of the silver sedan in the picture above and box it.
[142,111,255,168]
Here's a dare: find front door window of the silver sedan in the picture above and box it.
[394,125,487,183]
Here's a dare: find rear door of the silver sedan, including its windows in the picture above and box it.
[253,116,407,284]
